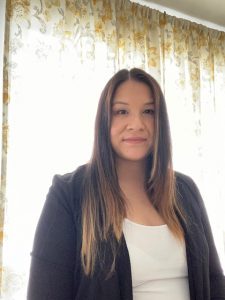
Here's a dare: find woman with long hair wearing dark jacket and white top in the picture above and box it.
[28,69,225,300]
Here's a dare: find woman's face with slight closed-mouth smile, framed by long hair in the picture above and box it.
[110,80,154,161]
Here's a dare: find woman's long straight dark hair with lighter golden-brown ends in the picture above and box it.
[81,68,184,275]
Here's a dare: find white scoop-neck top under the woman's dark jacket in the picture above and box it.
[123,219,190,300]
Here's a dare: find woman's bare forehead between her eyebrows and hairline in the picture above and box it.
[113,79,153,103]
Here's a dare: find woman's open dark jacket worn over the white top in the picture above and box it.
[27,166,225,300]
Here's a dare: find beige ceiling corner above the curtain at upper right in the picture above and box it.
[141,0,225,31]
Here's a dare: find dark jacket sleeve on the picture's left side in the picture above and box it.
[27,176,76,300]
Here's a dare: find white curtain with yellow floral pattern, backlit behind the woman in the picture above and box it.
[0,0,225,300]
